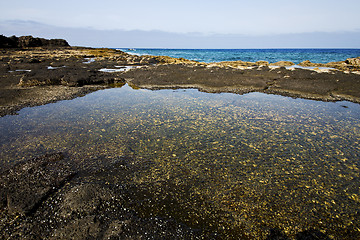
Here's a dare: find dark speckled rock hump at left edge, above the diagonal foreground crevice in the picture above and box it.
[0,153,75,215]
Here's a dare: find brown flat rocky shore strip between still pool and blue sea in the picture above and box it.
[0,47,360,116]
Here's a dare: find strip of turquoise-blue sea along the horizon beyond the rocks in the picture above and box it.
[120,48,360,64]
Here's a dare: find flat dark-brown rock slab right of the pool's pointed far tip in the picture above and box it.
[122,64,360,102]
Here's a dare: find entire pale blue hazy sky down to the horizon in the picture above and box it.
[0,0,360,48]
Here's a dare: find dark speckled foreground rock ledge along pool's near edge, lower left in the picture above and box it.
[0,153,329,240]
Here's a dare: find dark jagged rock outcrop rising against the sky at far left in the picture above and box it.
[0,35,70,48]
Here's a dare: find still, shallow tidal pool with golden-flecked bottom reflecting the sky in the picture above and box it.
[0,85,360,239]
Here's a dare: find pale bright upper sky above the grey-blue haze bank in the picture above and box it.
[0,0,360,35]
